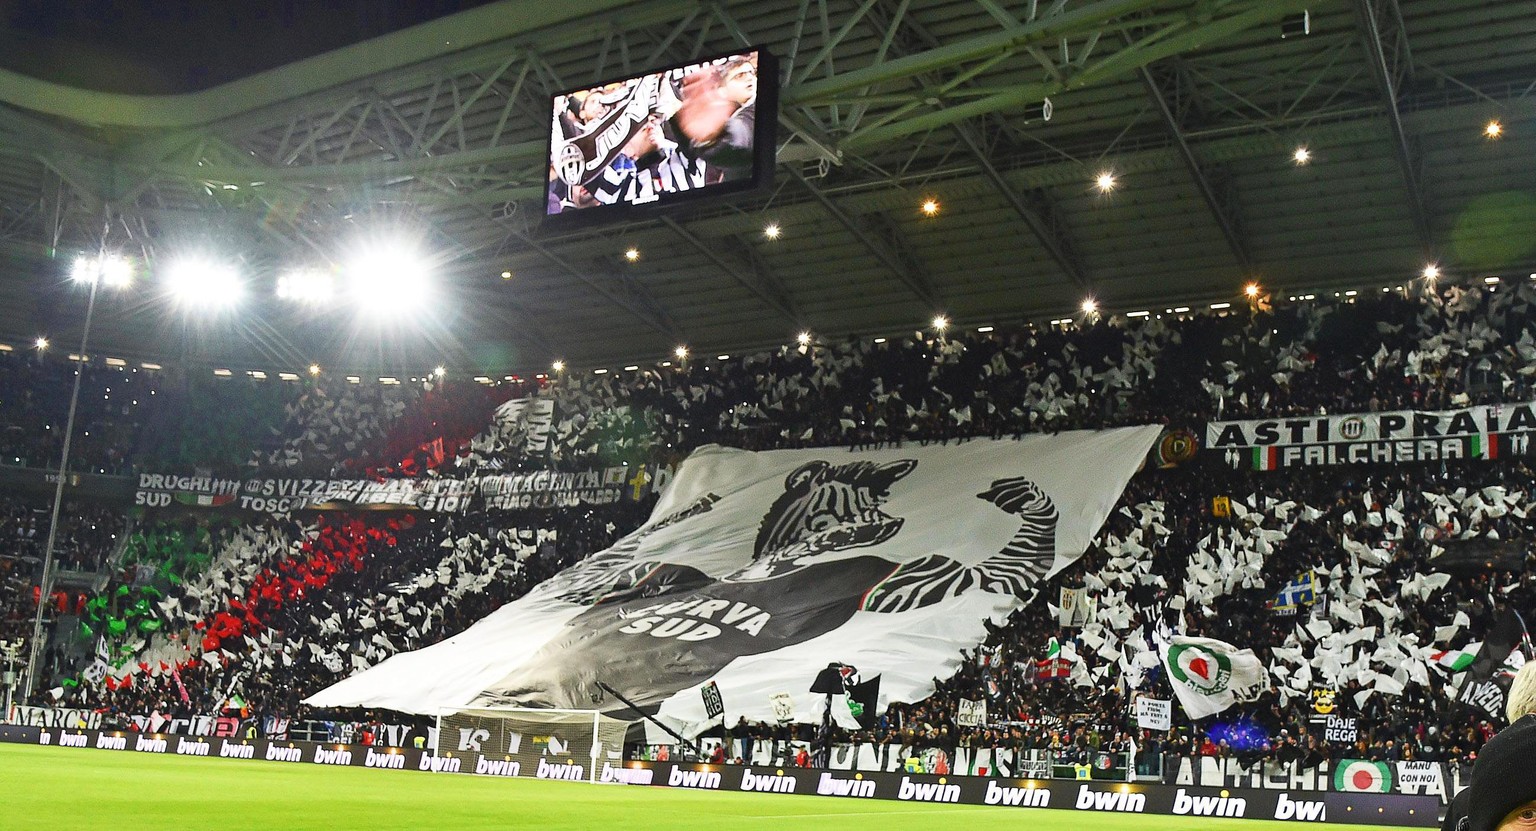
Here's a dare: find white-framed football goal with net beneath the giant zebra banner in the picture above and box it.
[433,707,630,782]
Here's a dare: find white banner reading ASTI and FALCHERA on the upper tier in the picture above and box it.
[1206,402,1536,470]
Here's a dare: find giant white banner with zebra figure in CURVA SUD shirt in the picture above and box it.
[309,425,1160,730]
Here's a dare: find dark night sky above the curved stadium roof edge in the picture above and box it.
[0,0,490,94]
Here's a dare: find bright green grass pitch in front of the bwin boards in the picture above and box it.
[0,743,1413,831]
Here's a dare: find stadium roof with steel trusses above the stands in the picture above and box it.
[0,0,1536,373]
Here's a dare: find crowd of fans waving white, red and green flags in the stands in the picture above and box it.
[0,279,1536,777]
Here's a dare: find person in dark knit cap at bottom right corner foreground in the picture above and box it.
[1441,662,1536,831]
